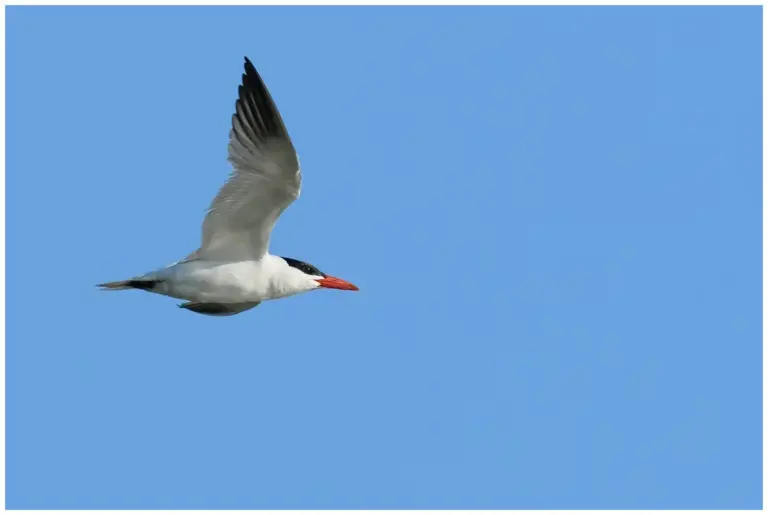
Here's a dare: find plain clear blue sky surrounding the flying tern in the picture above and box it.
[6,7,762,509]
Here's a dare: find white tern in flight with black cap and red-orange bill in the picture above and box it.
[97,56,359,316]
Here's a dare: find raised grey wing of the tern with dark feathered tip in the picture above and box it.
[198,57,301,261]
